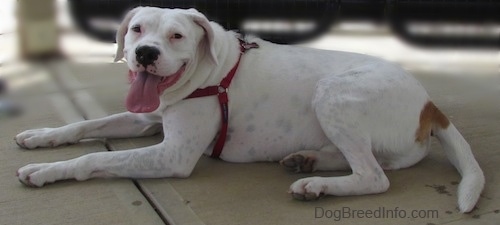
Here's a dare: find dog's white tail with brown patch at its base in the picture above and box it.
[430,102,484,213]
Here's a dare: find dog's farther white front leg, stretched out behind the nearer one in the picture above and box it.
[15,112,161,149]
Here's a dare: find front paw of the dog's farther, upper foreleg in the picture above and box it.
[14,128,73,149]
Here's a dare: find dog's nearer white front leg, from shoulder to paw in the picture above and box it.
[17,100,220,187]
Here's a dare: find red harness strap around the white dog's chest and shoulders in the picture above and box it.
[185,39,259,158]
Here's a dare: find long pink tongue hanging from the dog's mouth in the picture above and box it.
[126,72,161,113]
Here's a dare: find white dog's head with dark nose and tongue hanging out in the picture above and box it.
[115,7,217,113]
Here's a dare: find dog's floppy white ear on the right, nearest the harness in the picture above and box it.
[187,8,218,65]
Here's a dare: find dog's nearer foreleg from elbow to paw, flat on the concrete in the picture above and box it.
[17,143,191,187]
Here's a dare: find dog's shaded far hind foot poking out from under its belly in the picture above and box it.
[280,145,350,173]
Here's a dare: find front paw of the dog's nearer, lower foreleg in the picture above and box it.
[16,163,57,187]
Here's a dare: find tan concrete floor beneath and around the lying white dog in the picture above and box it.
[0,25,500,225]
